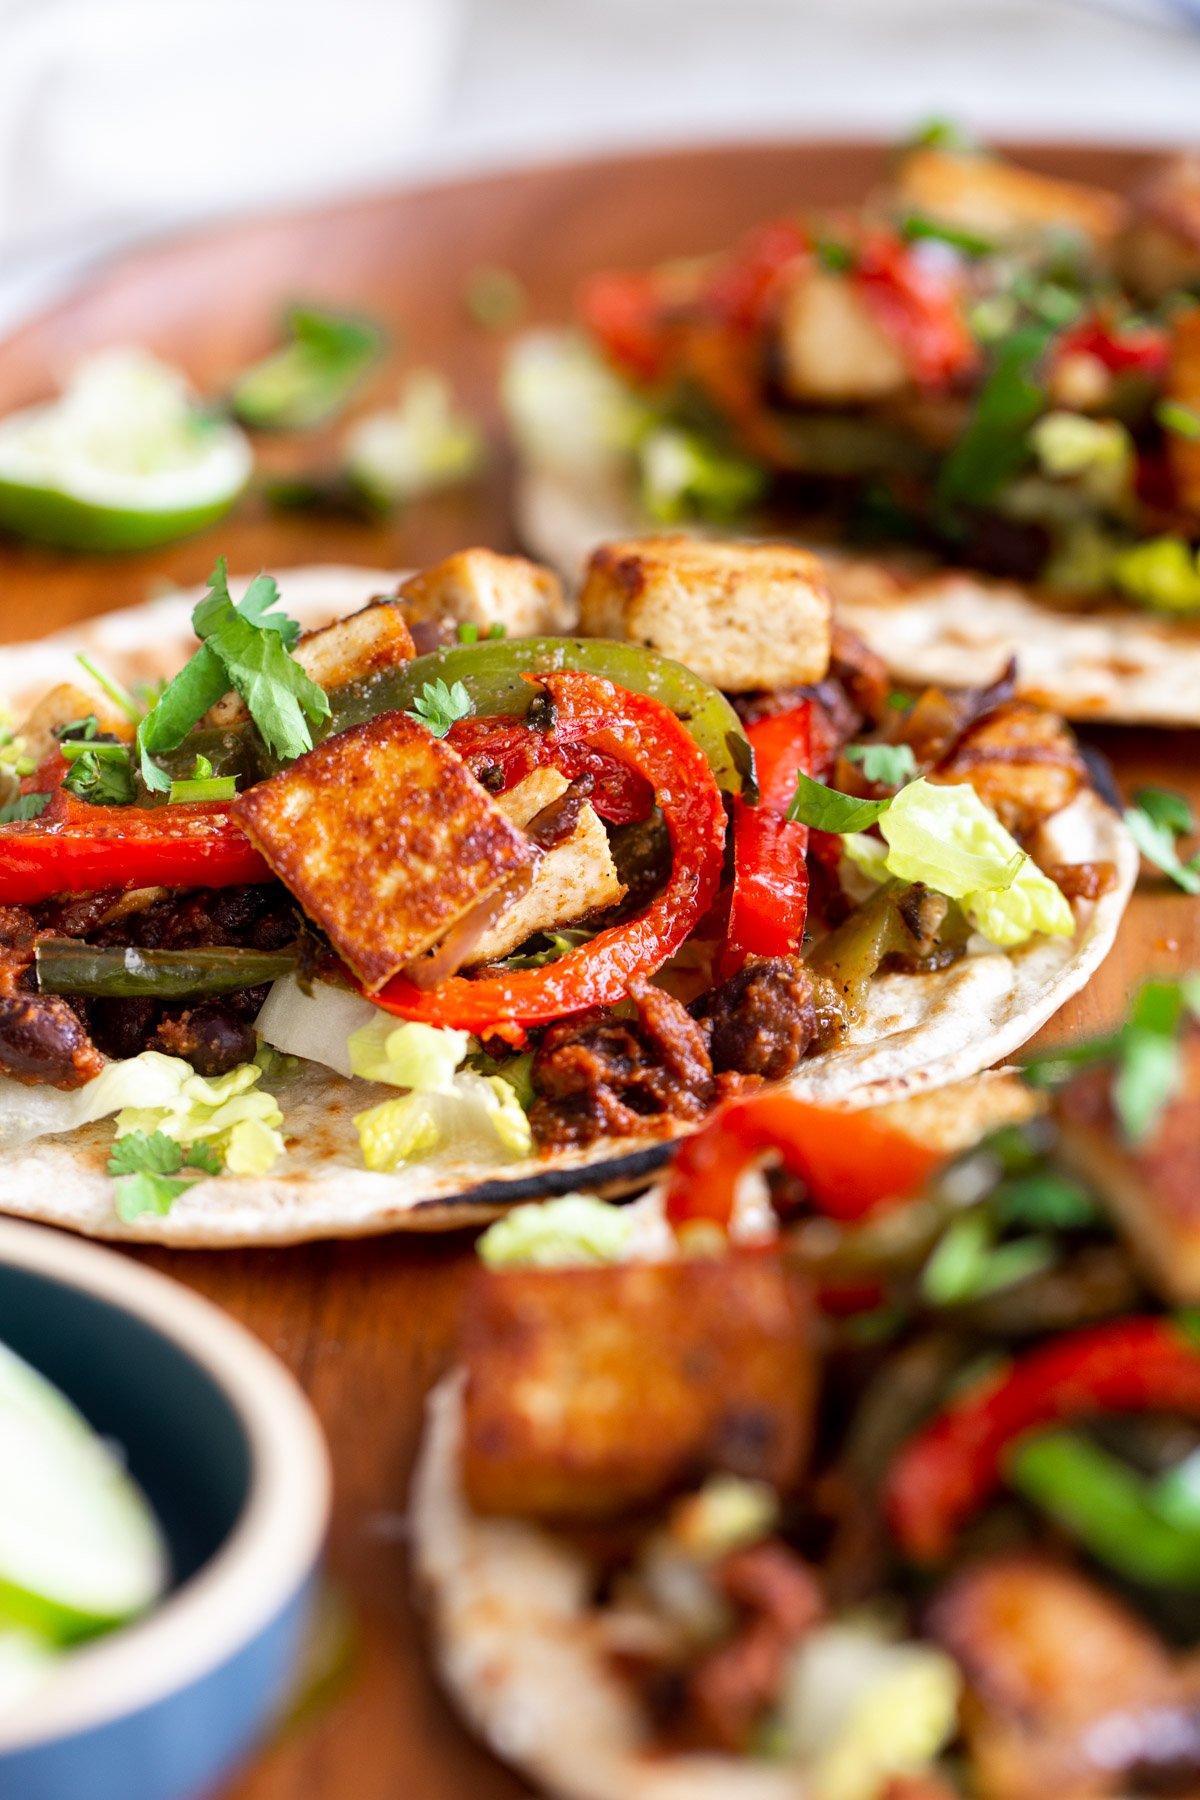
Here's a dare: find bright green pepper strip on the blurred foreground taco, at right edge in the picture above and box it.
[1004,1431,1200,1591]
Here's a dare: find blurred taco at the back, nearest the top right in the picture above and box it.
[504,140,1200,725]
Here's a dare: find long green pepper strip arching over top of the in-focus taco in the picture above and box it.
[314,637,757,801]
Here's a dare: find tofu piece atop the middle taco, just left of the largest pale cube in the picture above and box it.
[399,549,572,637]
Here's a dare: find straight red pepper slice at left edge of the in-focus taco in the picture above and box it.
[0,788,273,905]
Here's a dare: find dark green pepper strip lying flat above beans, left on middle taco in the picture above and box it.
[34,938,297,1001]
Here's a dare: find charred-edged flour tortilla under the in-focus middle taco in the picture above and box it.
[0,567,1137,1246]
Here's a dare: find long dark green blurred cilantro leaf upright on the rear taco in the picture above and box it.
[937,326,1052,515]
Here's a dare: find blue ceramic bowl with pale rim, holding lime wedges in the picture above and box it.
[0,1220,329,1800]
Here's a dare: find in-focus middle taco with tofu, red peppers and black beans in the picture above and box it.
[0,542,1137,1244]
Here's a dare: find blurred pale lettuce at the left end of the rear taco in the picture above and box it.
[500,331,653,475]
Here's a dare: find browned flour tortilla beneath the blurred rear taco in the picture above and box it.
[516,468,1200,725]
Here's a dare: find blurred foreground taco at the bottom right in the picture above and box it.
[410,990,1200,1800]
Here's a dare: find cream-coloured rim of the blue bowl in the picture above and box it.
[0,1219,333,1768]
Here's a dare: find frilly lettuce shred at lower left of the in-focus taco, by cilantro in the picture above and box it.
[115,1051,282,1175]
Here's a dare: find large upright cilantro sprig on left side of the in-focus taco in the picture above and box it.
[137,556,329,794]
